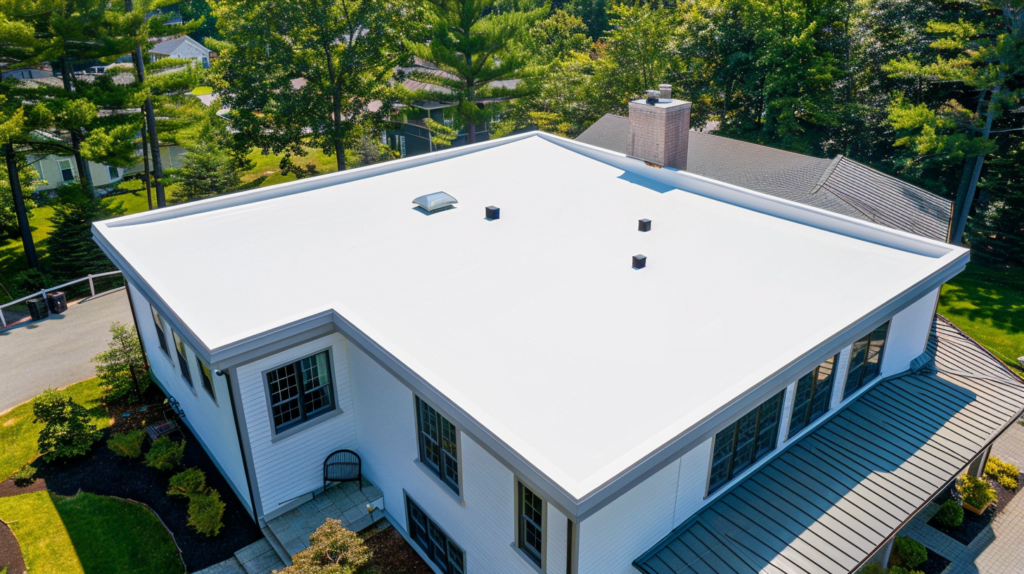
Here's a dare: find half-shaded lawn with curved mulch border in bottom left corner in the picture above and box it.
[0,491,183,574]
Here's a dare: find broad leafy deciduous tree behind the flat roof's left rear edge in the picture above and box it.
[213,0,409,170]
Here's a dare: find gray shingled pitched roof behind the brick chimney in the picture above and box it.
[577,114,952,241]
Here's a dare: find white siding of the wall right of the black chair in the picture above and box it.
[349,345,540,574]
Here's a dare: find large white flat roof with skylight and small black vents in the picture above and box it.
[96,133,964,499]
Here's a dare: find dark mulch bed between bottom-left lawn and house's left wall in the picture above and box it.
[0,429,263,572]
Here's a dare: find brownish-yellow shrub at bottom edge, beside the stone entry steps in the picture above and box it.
[279,518,373,574]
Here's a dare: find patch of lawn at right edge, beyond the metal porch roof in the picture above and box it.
[939,263,1024,372]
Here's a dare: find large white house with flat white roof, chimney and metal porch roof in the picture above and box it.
[93,89,1024,574]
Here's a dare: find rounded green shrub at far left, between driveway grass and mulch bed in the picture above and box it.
[32,389,101,461]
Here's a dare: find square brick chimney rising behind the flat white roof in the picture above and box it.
[628,84,690,170]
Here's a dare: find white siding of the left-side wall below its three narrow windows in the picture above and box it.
[128,283,252,512]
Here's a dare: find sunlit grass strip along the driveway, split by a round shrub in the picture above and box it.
[0,379,111,480]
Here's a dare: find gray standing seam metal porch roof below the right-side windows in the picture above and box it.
[634,315,1024,574]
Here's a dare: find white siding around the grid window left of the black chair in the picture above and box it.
[237,335,358,516]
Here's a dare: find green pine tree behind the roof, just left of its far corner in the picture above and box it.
[407,0,550,143]
